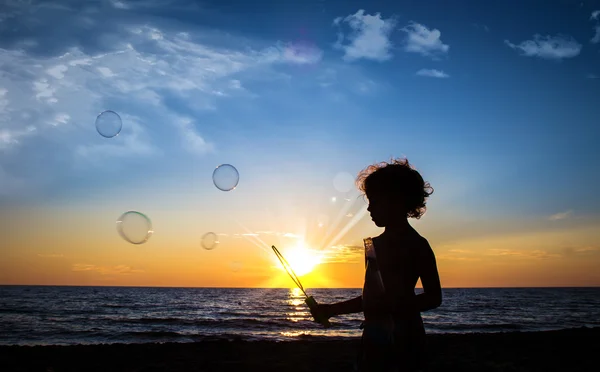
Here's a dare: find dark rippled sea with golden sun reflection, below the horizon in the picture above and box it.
[0,286,600,345]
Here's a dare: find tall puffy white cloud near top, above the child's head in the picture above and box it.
[333,9,396,62]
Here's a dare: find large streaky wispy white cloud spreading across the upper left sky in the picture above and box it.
[0,26,322,155]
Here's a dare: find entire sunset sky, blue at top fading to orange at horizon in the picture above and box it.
[0,0,600,288]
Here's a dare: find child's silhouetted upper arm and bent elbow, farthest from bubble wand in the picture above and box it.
[415,243,442,312]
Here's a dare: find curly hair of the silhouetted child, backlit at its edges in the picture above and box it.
[356,158,433,219]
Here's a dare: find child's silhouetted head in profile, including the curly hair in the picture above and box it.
[356,159,433,227]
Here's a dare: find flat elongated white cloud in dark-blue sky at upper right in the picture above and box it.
[504,34,581,60]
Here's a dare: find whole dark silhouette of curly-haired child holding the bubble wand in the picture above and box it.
[316,159,442,371]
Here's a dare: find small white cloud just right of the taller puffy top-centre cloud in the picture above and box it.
[402,22,450,58]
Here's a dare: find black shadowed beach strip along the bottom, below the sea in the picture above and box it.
[0,328,600,372]
